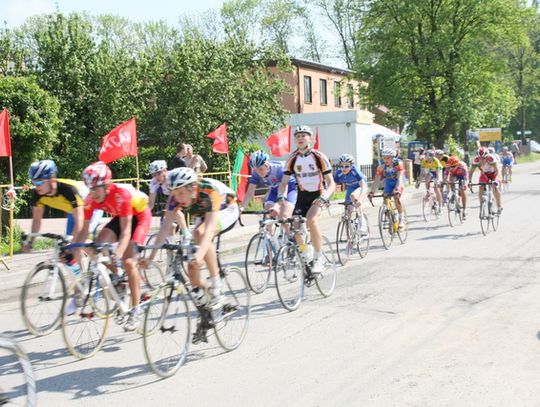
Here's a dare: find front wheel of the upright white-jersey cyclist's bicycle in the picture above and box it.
[274,243,304,311]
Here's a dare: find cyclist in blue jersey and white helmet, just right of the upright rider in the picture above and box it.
[334,154,367,235]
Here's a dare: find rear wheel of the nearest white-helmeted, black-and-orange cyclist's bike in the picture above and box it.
[214,266,251,351]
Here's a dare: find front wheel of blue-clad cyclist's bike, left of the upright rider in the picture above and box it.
[244,233,273,294]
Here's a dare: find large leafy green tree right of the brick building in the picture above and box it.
[356,0,521,146]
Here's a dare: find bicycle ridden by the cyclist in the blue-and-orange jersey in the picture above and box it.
[368,194,409,250]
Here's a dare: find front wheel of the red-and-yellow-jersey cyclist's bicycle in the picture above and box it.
[62,273,110,359]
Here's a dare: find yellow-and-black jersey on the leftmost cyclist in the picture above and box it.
[30,178,88,213]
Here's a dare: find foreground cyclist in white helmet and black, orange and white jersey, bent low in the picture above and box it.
[140,167,240,309]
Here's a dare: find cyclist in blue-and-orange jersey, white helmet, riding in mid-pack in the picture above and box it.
[369,148,404,229]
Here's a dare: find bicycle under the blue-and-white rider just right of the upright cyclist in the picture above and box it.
[336,202,370,266]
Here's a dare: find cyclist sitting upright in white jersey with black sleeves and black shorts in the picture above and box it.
[277,126,336,274]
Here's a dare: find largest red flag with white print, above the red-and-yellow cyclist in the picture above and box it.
[99,118,138,164]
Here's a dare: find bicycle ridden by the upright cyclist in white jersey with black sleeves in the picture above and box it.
[274,215,337,311]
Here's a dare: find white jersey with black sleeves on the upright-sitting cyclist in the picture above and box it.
[284,149,332,192]
